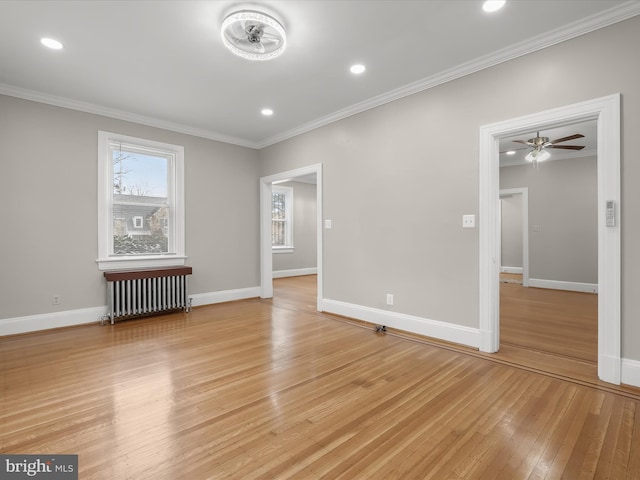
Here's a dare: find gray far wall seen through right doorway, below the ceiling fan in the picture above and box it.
[500,157,598,284]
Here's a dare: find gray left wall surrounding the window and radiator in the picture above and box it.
[0,96,260,320]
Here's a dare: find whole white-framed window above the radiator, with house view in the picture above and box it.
[98,132,185,270]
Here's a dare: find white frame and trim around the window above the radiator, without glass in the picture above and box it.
[96,131,187,271]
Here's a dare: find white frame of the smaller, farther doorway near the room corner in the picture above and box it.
[260,163,323,311]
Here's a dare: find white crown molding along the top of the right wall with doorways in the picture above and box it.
[257,0,640,148]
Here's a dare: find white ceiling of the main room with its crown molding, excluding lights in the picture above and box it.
[0,0,640,148]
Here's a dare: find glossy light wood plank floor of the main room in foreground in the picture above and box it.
[0,277,640,480]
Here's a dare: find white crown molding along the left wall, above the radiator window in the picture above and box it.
[0,83,258,149]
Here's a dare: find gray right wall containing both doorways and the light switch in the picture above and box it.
[260,17,640,360]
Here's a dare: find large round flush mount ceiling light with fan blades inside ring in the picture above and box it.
[221,10,287,60]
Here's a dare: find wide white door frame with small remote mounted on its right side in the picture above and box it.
[479,93,622,384]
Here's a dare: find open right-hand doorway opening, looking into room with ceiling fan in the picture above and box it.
[500,130,598,364]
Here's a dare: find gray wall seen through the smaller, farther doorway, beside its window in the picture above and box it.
[273,182,318,272]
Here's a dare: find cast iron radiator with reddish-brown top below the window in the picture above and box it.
[104,267,192,324]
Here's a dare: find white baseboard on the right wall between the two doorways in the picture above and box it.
[322,298,480,348]
